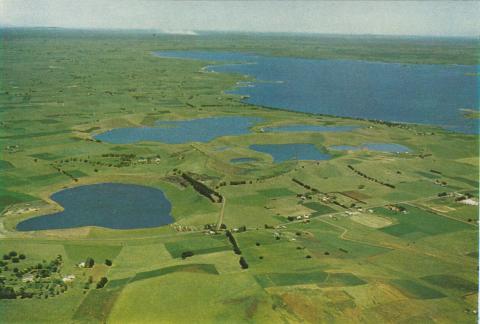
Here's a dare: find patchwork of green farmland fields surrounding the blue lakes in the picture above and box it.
[0,29,479,323]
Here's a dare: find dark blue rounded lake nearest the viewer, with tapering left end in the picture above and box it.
[17,183,173,231]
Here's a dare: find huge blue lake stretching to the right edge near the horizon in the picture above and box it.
[156,51,479,133]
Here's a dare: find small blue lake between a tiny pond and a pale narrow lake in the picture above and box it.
[250,143,330,163]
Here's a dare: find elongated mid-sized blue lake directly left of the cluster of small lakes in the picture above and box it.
[95,117,260,144]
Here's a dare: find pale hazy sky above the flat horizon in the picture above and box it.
[0,0,480,36]
